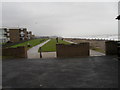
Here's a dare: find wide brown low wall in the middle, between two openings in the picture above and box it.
[56,43,89,58]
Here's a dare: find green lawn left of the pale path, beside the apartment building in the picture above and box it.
[11,39,47,49]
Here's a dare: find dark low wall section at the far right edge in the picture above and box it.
[105,41,118,55]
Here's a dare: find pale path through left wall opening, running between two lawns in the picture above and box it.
[27,39,51,59]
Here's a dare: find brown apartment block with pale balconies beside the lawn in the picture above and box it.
[1,28,32,42]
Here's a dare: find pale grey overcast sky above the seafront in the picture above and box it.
[2,2,118,37]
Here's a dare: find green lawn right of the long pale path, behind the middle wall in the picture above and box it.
[38,39,70,52]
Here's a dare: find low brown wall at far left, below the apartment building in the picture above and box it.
[2,47,27,58]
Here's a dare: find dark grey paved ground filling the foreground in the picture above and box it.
[2,56,119,88]
